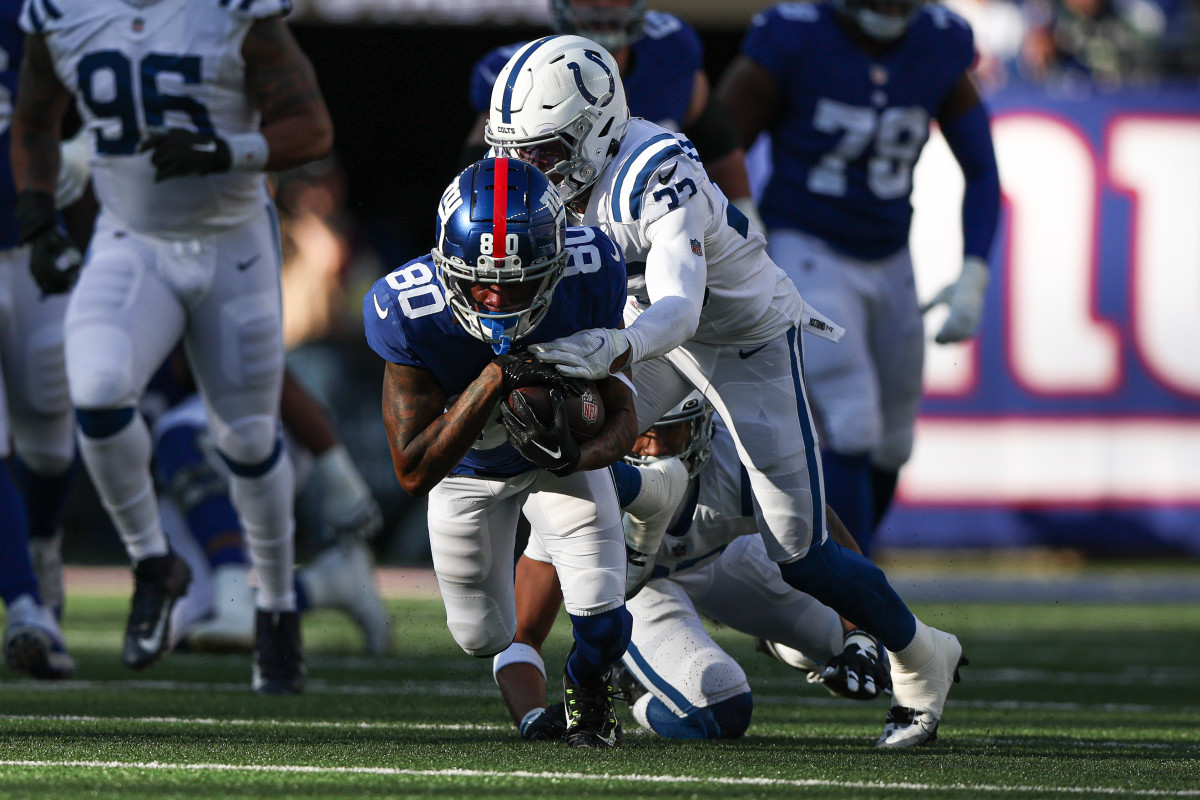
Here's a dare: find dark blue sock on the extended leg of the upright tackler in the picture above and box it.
[779,539,917,652]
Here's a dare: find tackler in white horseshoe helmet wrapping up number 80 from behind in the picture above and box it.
[486,36,962,747]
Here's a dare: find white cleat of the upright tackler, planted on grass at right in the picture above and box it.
[875,627,967,748]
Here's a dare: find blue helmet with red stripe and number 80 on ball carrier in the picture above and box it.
[432,158,570,354]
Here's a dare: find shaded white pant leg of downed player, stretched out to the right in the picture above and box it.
[673,535,842,662]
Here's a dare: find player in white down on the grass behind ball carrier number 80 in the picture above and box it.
[493,392,890,740]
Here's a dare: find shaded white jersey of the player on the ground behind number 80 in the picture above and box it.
[655,419,758,577]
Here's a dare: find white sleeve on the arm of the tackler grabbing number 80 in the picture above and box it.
[625,196,710,363]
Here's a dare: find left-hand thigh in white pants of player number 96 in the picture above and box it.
[65,220,186,409]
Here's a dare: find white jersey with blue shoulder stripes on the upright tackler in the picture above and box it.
[581,119,803,344]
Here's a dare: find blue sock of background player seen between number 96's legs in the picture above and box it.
[154,425,247,569]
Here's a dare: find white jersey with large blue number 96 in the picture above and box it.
[20,0,284,239]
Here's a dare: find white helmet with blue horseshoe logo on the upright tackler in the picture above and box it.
[484,36,629,201]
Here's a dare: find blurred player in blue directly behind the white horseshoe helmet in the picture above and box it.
[463,0,761,231]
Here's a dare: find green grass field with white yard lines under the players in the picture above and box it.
[0,568,1200,800]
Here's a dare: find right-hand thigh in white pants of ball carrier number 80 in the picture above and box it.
[524,469,625,616]
